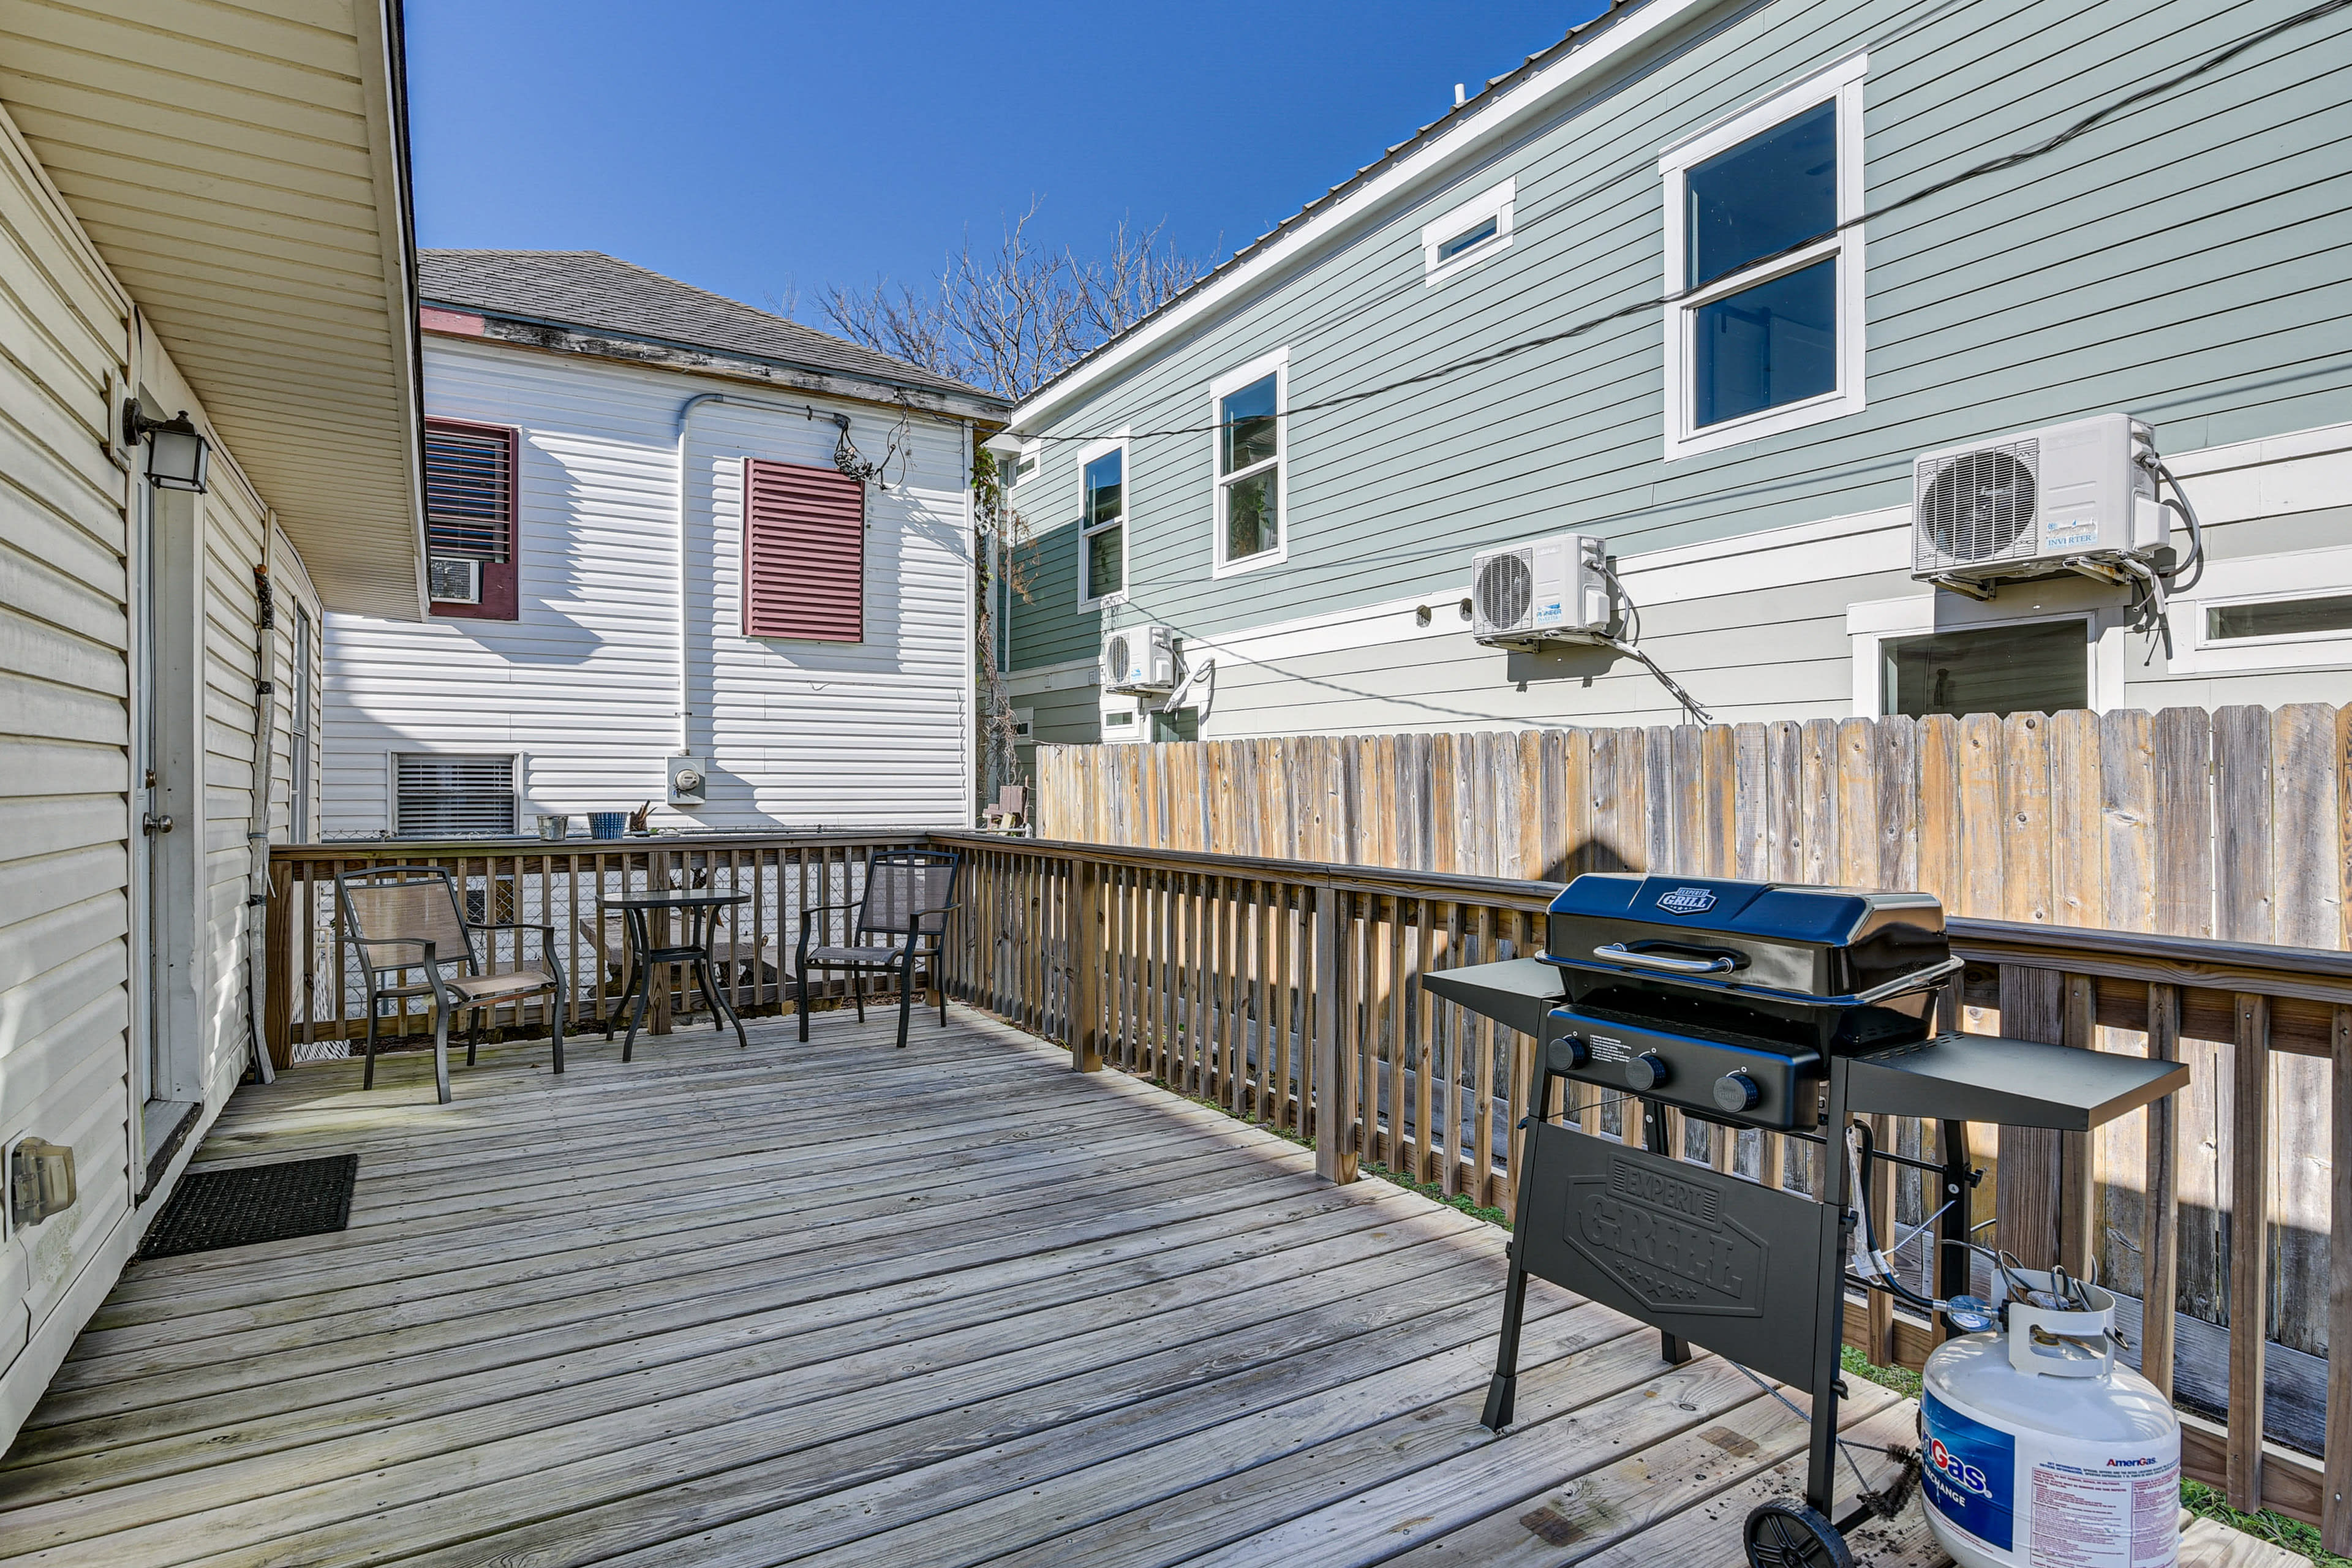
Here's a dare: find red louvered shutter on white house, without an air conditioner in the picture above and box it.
[743,458,865,642]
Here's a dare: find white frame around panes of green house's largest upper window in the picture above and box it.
[1658,54,1870,463]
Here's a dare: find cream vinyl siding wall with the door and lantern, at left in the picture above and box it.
[0,92,331,1444]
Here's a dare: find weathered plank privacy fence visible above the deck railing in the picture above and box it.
[1037,703,2352,948]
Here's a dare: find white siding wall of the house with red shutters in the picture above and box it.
[320,336,971,837]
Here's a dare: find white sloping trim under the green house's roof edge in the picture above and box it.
[1009,0,1719,428]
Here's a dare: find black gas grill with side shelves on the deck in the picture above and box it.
[1425,875,2187,1566]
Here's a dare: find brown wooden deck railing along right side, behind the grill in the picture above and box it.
[932,835,2352,1545]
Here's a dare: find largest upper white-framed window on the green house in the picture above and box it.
[1658,54,1868,461]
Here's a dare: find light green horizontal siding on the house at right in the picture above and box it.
[1014,0,2352,733]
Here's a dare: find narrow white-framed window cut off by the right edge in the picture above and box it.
[2168,545,2352,675]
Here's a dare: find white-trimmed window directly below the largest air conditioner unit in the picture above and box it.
[1846,595,2128,719]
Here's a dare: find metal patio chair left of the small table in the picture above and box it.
[334,865,571,1105]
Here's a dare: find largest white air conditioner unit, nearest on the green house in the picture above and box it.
[1912,414,2173,597]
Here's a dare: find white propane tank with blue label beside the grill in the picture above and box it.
[1919,1270,2180,1568]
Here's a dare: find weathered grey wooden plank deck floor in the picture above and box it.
[0,1011,2251,1568]
